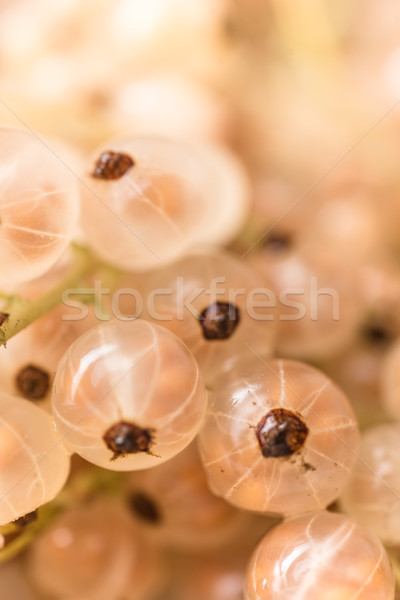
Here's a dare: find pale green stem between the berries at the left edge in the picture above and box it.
[0,244,117,346]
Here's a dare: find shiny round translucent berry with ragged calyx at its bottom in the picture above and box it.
[52,320,206,471]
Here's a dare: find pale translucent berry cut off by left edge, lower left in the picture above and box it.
[0,394,70,525]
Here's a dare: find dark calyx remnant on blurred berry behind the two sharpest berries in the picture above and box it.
[199,302,240,340]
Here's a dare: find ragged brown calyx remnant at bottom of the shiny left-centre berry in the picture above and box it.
[103,421,153,460]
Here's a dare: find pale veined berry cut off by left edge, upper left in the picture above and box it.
[0,127,79,285]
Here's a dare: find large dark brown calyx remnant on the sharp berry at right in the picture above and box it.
[256,408,308,458]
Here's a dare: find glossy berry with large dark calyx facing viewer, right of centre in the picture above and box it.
[199,360,359,515]
